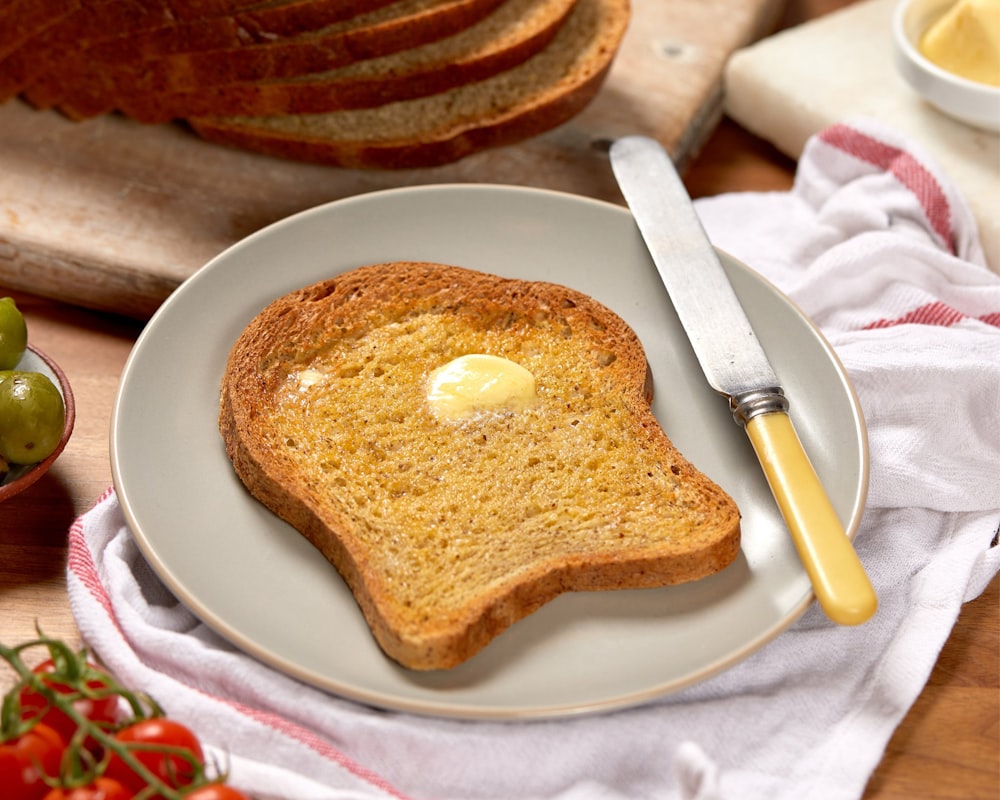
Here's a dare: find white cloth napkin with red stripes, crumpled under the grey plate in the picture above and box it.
[68,120,1000,800]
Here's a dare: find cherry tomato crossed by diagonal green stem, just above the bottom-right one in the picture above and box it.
[104,717,205,792]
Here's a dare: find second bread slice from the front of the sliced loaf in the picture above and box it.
[116,0,576,123]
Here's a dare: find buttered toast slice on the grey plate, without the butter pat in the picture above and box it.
[219,262,740,670]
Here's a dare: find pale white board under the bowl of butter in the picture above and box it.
[725,0,1000,272]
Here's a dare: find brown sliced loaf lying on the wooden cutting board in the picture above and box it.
[0,0,630,169]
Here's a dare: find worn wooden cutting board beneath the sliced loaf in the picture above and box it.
[0,0,784,318]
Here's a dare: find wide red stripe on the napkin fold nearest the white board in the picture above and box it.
[819,124,956,255]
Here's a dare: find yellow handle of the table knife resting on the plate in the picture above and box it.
[746,411,878,625]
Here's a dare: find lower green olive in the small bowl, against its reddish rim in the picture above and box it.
[0,370,66,464]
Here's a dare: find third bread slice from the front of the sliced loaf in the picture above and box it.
[40,0,503,119]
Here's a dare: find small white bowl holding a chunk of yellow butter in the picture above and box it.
[893,0,1000,131]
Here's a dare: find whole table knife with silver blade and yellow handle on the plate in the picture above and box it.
[610,136,878,625]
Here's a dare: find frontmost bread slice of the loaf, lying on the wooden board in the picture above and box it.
[188,0,629,169]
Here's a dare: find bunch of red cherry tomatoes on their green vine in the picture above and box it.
[0,632,249,800]
